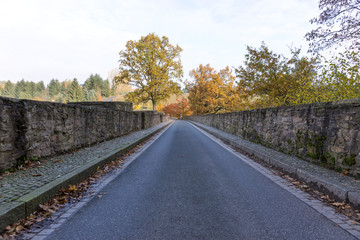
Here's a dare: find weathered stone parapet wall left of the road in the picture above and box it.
[0,97,169,169]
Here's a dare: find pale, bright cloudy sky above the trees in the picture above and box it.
[0,0,319,83]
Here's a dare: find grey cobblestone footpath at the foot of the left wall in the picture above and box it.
[0,122,169,232]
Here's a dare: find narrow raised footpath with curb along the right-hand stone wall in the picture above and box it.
[189,121,360,210]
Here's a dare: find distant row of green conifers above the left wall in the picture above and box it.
[0,74,115,103]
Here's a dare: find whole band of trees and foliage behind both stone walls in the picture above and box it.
[0,0,360,115]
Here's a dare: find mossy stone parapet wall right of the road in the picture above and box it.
[187,98,360,176]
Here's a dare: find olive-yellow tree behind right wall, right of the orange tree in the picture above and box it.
[235,43,318,108]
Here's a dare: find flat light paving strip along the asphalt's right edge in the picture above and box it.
[188,124,360,239]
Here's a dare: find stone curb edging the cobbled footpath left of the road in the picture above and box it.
[0,121,173,233]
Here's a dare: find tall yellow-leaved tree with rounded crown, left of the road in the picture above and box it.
[114,33,183,110]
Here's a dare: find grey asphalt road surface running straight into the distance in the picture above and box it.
[48,121,354,240]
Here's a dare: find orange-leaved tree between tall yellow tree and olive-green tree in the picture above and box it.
[187,64,241,114]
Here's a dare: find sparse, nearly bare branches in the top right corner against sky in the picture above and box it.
[305,0,360,52]
